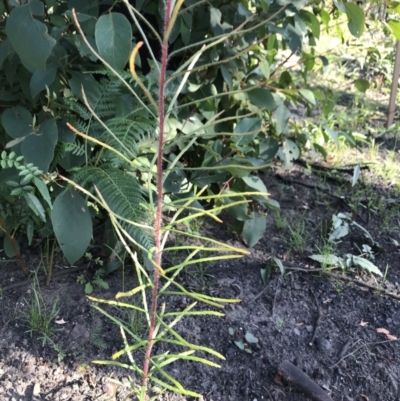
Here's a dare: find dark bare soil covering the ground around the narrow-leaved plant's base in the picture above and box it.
[0,161,400,401]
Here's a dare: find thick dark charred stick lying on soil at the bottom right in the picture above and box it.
[278,361,333,401]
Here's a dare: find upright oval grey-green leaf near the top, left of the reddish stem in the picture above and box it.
[95,13,132,70]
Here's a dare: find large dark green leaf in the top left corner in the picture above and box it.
[6,0,56,72]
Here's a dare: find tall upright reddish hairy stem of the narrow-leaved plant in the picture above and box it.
[143,0,172,392]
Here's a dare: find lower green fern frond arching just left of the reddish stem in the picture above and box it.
[73,165,153,249]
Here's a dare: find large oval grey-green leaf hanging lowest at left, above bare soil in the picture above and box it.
[51,189,93,265]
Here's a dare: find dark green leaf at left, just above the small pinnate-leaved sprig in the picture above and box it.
[21,118,58,173]
